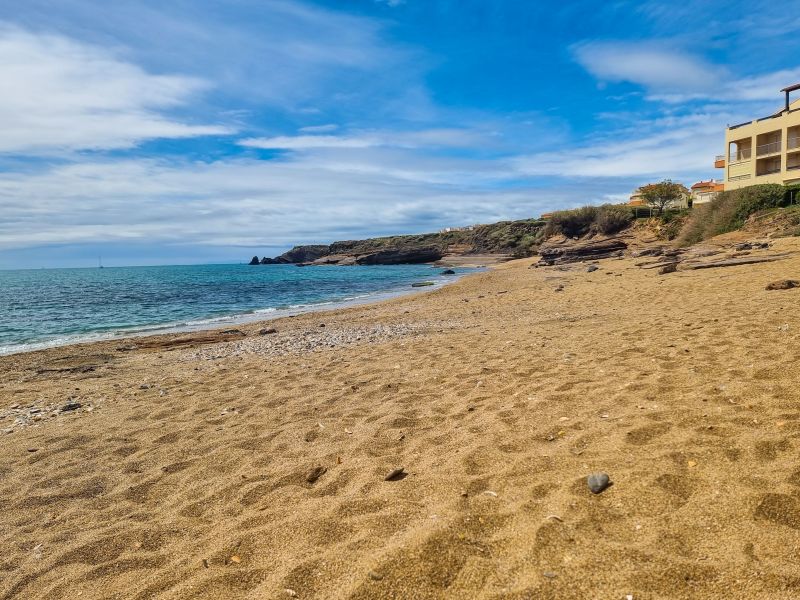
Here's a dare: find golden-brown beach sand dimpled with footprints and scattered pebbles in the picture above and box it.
[0,239,800,600]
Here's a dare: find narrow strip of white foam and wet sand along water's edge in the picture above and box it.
[0,265,482,357]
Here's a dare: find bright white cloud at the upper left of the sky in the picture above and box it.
[0,26,231,153]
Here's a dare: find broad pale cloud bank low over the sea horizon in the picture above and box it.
[0,148,600,251]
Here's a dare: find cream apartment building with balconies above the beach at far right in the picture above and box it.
[714,83,800,190]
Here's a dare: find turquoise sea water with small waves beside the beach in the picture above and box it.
[0,265,466,354]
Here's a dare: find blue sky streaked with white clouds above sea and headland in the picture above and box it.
[0,0,800,268]
